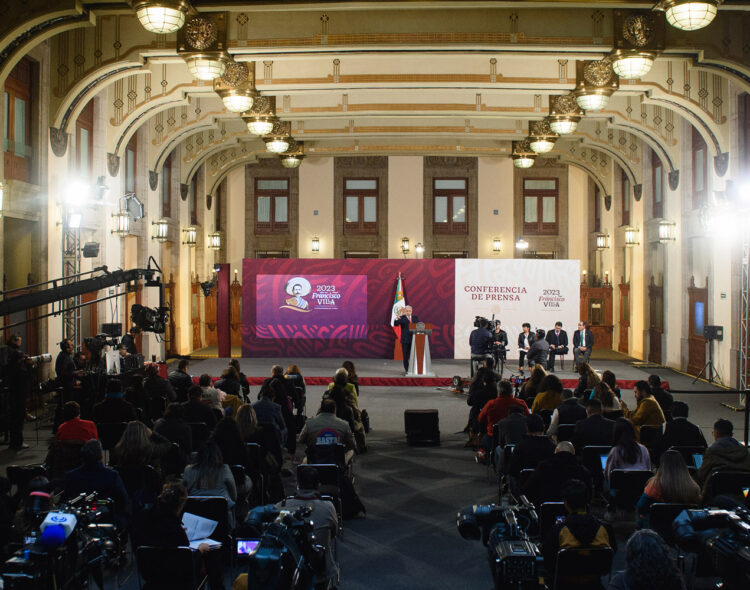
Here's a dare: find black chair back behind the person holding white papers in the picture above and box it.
[135,546,208,590]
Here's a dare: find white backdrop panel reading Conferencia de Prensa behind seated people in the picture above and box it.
[454,259,581,359]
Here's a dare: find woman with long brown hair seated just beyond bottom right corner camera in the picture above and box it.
[636,451,701,527]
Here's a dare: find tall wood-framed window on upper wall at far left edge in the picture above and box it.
[3,58,34,182]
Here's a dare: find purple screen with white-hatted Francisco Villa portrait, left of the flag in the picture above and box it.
[255,274,367,340]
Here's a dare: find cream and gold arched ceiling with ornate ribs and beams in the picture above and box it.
[0,0,750,192]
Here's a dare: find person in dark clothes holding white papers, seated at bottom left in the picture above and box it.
[130,482,224,590]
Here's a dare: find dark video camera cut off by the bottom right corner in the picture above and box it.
[673,507,750,590]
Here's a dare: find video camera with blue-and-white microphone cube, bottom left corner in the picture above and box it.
[2,492,120,590]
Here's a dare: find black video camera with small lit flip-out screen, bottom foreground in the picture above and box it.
[242,505,326,590]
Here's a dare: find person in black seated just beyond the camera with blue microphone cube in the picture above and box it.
[63,440,130,526]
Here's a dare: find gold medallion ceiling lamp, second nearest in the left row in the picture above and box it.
[177,12,231,80]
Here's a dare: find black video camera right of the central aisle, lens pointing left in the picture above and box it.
[456,496,543,590]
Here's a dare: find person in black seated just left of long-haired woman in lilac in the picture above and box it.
[521,441,591,506]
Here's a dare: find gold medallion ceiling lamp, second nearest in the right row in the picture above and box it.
[607,10,666,80]
